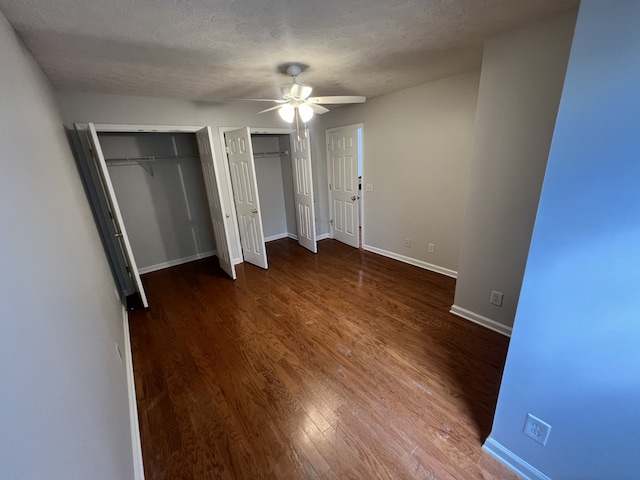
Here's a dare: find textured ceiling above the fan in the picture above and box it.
[0,0,578,101]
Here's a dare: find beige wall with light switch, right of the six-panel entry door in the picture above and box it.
[314,72,479,274]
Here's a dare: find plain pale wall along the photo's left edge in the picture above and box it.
[0,13,133,480]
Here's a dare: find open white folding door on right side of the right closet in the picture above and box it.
[292,135,318,253]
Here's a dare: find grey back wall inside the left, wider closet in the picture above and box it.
[99,133,215,273]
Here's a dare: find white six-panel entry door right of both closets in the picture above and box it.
[327,126,360,248]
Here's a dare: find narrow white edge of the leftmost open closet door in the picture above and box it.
[86,123,149,308]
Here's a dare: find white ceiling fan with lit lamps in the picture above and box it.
[245,64,366,123]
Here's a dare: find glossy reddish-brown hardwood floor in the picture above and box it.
[130,239,518,480]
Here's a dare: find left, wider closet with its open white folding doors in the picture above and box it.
[75,123,236,309]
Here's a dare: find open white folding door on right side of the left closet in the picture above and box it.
[196,127,236,280]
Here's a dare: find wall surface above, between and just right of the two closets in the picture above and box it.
[57,92,328,258]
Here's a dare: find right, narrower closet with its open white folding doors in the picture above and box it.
[220,127,317,268]
